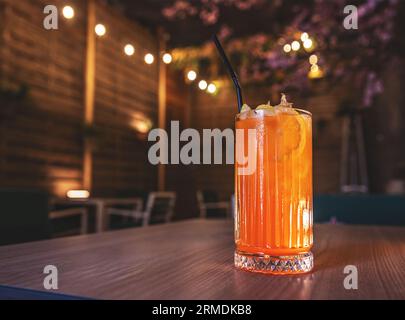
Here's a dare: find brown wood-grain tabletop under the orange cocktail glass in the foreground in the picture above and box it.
[0,220,405,299]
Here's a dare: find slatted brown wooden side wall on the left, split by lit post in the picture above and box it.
[0,0,158,196]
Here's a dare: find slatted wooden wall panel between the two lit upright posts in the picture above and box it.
[93,2,158,194]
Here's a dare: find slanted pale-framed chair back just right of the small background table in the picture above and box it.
[143,192,176,225]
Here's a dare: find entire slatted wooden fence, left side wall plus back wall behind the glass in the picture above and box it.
[0,0,399,210]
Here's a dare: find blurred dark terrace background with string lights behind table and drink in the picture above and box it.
[0,0,405,243]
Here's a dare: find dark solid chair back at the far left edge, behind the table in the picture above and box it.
[0,189,51,245]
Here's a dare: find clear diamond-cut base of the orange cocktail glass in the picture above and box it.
[235,251,314,275]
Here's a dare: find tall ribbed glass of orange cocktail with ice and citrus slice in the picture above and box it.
[235,97,313,274]
